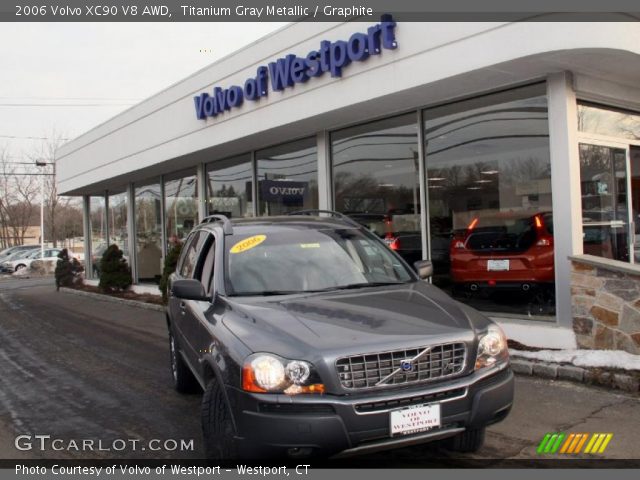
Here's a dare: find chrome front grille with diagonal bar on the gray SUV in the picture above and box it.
[336,342,466,389]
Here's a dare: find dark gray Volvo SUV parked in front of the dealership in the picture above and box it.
[167,211,513,459]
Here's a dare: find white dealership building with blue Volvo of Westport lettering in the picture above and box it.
[56,16,640,353]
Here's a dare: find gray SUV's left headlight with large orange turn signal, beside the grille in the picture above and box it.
[242,353,324,395]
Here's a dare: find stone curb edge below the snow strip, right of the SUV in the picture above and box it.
[511,356,640,393]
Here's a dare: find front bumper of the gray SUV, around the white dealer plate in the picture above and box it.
[229,366,514,458]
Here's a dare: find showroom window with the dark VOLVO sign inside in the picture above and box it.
[256,137,318,215]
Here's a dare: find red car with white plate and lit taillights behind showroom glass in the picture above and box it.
[449,212,554,292]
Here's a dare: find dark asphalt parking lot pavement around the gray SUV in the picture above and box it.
[0,279,640,464]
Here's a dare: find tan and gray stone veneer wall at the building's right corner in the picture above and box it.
[570,255,640,354]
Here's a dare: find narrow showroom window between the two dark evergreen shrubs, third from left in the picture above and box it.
[135,183,162,282]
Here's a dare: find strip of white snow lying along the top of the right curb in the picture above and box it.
[509,349,640,370]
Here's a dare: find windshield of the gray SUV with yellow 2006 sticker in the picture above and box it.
[225,227,415,295]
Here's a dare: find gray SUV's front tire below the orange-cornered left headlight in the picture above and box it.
[201,380,239,460]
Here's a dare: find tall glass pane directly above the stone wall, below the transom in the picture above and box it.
[580,143,640,262]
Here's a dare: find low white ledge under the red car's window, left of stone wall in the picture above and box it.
[492,317,578,349]
